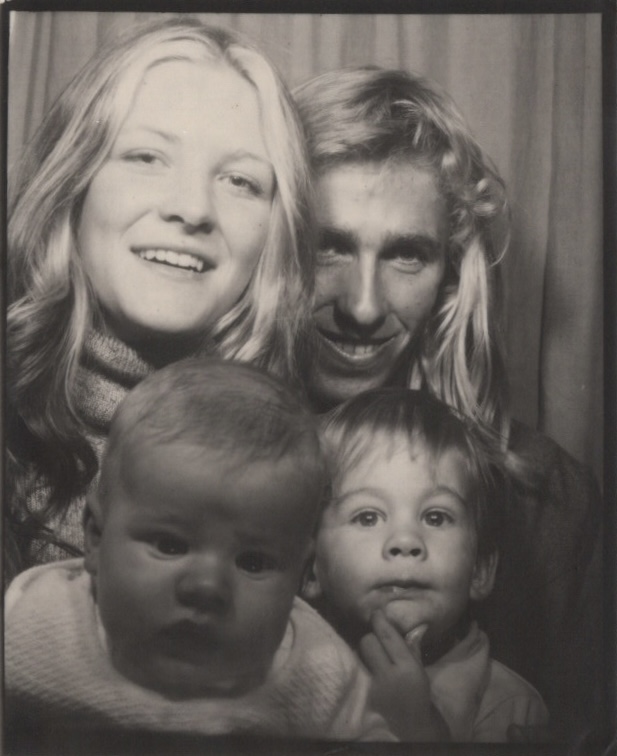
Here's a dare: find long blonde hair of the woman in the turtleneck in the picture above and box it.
[7,16,314,524]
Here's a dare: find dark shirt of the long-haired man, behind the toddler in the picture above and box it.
[479,423,610,746]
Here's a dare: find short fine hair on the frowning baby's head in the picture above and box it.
[98,357,327,508]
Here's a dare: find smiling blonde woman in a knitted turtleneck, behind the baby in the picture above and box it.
[6,17,312,578]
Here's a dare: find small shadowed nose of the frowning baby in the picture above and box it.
[176,554,232,614]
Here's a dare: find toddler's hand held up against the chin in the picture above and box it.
[360,609,449,742]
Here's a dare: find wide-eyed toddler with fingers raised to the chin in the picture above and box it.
[305,389,547,742]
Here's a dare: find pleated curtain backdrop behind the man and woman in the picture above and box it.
[8,11,603,478]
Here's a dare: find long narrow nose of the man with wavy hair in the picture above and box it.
[338,256,387,329]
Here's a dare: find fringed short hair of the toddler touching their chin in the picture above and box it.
[321,388,505,557]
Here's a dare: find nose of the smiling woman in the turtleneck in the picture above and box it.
[159,167,215,233]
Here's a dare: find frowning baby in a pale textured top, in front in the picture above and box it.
[5,359,393,740]
